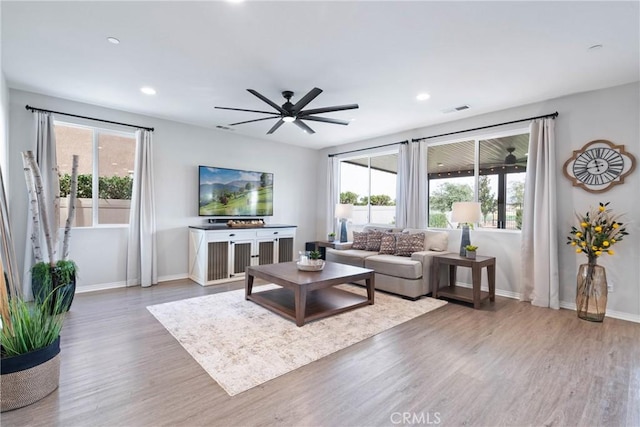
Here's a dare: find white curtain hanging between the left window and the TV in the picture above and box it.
[127,129,158,287]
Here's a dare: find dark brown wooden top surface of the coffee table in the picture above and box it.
[246,261,373,286]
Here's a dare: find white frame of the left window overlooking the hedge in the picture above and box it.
[53,119,137,230]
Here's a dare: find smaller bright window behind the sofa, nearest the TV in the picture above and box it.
[340,152,398,225]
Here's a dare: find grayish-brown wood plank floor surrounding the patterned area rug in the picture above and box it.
[0,280,640,427]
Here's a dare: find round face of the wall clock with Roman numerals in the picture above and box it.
[573,147,624,185]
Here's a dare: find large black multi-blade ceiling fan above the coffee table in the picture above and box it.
[215,87,358,135]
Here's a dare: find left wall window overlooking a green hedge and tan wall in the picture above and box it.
[55,122,136,227]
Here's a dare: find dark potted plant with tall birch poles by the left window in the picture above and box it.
[22,151,78,311]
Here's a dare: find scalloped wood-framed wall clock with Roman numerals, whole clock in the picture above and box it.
[562,139,636,193]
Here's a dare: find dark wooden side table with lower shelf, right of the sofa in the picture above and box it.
[431,253,496,309]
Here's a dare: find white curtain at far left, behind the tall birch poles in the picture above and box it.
[22,111,60,298]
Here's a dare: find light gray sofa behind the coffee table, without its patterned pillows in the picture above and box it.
[326,226,449,300]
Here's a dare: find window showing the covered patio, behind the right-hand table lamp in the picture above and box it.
[427,131,529,230]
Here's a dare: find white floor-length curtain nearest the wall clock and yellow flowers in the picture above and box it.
[521,118,560,309]
